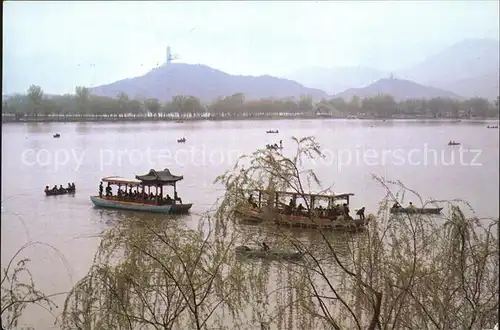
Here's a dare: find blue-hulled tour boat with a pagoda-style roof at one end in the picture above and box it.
[90,169,193,214]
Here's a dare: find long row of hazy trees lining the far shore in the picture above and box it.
[2,85,499,120]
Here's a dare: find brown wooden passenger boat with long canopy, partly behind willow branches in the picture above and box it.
[235,190,375,231]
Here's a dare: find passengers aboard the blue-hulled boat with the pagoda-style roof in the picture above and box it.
[99,181,182,205]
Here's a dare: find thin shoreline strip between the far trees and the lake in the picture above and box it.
[2,115,500,125]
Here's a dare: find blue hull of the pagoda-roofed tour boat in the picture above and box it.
[90,196,193,214]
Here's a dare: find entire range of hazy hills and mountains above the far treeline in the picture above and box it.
[3,39,500,102]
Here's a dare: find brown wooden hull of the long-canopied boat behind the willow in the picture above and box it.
[236,209,375,231]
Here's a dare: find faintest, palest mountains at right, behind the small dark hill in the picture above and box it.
[287,39,500,99]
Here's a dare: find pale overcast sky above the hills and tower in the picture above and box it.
[2,0,499,94]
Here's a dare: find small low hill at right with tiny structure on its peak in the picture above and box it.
[335,78,459,101]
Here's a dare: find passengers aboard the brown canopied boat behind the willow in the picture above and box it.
[248,195,365,220]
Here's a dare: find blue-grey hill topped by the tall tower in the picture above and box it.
[90,63,328,101]
